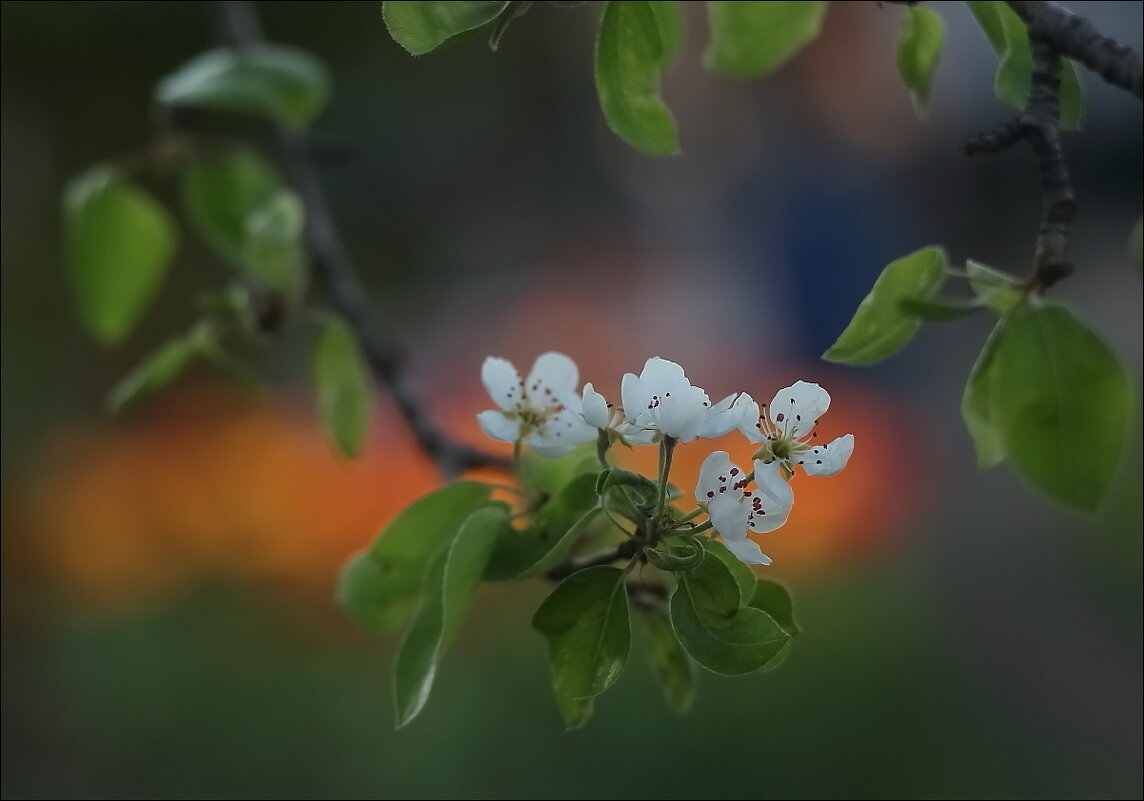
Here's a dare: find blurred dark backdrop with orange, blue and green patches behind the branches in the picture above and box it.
[0,2,1142,798]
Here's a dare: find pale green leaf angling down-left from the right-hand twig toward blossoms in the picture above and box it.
[823,247,946,366]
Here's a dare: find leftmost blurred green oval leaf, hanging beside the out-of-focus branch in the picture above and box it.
[64,167,176,344]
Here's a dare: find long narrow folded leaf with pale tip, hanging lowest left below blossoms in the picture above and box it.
[394,503,509,729]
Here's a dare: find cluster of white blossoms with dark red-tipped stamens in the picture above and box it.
[477,352,853,564]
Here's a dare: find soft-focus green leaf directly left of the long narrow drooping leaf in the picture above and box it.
[336,482,492,632]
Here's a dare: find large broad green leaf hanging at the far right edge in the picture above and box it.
[990,306,1136,510]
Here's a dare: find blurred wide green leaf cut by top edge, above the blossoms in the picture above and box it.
[704,0,826,78]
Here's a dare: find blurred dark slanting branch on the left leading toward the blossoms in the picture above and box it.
[217,0,509,477]
